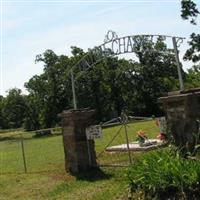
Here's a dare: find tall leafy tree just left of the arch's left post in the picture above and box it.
[25,50,72,129]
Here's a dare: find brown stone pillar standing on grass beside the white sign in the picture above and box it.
[61,109,97,173]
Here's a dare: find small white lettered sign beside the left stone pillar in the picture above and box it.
[86,125,102,140]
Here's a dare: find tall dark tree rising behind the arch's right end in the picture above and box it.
[130,37,178,116]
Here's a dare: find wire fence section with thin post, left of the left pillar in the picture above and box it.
[0,129,64,174]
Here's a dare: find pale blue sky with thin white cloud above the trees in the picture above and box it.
[0,0,200,96]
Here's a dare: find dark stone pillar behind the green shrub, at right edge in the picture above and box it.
[159,89,200,151]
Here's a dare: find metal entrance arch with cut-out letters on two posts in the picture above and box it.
[70,30,185,109]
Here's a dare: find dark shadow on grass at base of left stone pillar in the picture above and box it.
[72,168,112,182]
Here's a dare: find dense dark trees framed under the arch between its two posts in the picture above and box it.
[76,37,178,119]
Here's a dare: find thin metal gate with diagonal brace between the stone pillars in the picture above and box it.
[95,112,163,167]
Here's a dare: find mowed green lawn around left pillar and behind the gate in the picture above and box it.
[0,121,159,200]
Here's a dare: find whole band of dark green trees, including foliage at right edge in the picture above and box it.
[0,1,200,130]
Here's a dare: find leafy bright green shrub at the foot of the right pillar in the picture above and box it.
[126,149,200,200]
